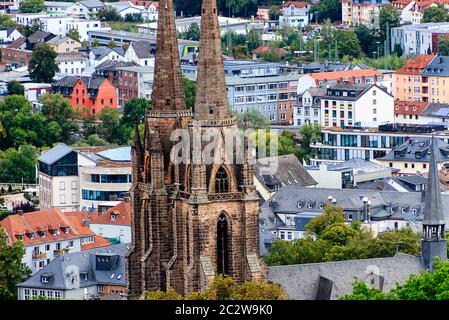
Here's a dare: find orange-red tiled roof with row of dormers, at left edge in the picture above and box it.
[0,209,79,246]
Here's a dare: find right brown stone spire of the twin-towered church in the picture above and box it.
[194,0,229,119]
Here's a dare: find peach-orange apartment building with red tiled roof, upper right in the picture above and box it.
[394,54,434,102]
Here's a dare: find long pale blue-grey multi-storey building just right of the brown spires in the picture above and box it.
[226,74,300,124]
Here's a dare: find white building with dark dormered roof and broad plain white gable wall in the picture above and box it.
[321,84,394,127]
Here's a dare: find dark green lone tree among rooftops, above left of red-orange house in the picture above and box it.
[28,43,59,83]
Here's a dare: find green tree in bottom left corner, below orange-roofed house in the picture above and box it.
[0,228,31,300]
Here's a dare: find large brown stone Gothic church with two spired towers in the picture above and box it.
[127,0,267,299]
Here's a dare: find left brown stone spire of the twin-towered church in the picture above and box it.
[152,0,186,111]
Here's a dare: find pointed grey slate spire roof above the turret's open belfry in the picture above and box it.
[423,136,445,226]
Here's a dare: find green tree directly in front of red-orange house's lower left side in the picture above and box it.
[39,93,79,143]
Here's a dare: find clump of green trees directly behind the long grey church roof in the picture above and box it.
[264,205,421,265]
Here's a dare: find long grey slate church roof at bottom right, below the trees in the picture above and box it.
[268,254,424,300]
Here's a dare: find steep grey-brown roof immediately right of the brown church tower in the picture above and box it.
[254,154,317,189]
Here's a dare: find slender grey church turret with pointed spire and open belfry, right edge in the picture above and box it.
[421,135,447,271]
